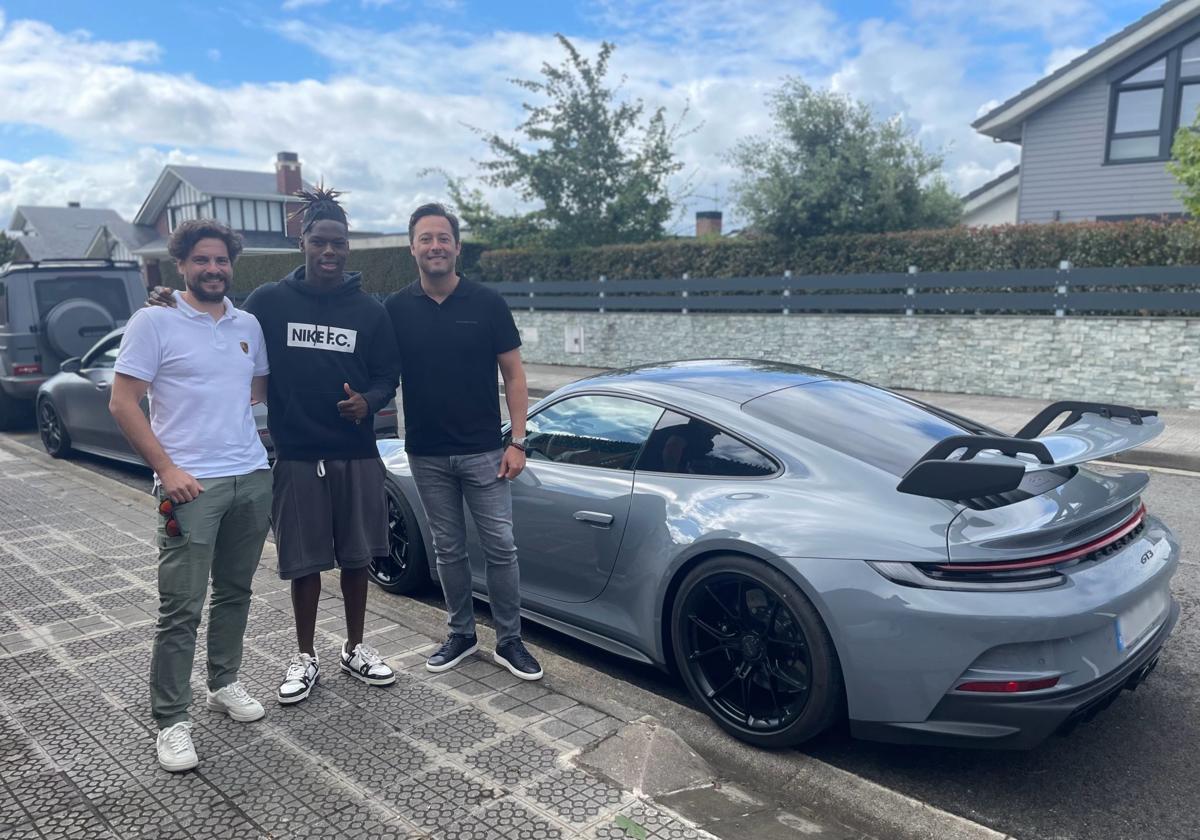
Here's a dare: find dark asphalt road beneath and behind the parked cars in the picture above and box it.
[8,431,1200,840]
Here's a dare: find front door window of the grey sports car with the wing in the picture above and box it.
[526,396,662,469]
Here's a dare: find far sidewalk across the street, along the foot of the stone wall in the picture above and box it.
[526,365,1200,472]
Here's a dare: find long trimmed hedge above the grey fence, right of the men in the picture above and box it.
[479,221,1200,281]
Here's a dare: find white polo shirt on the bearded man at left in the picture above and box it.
[116,294,270,479]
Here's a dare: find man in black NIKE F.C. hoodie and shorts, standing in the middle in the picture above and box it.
[150,188,398,704]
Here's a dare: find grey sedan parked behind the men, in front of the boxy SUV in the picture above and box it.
[36,328,397,466]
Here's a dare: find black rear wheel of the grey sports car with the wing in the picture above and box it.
[671,556,844,746]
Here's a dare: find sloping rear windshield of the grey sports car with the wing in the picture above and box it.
[742,379,977,476]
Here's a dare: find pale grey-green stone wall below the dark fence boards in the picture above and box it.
[514,310,1200,409]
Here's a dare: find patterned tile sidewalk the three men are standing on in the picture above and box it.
[0,443,840,840]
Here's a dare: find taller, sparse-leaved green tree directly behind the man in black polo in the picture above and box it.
[449,35,683,247]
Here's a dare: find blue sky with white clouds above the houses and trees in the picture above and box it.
[0,0,1158,232]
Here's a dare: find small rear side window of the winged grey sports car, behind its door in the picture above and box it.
[637,412,779,478]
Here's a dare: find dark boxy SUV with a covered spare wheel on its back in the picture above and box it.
[0,259,146,430]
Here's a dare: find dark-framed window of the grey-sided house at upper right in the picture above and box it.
[1108,38,1200,162]
